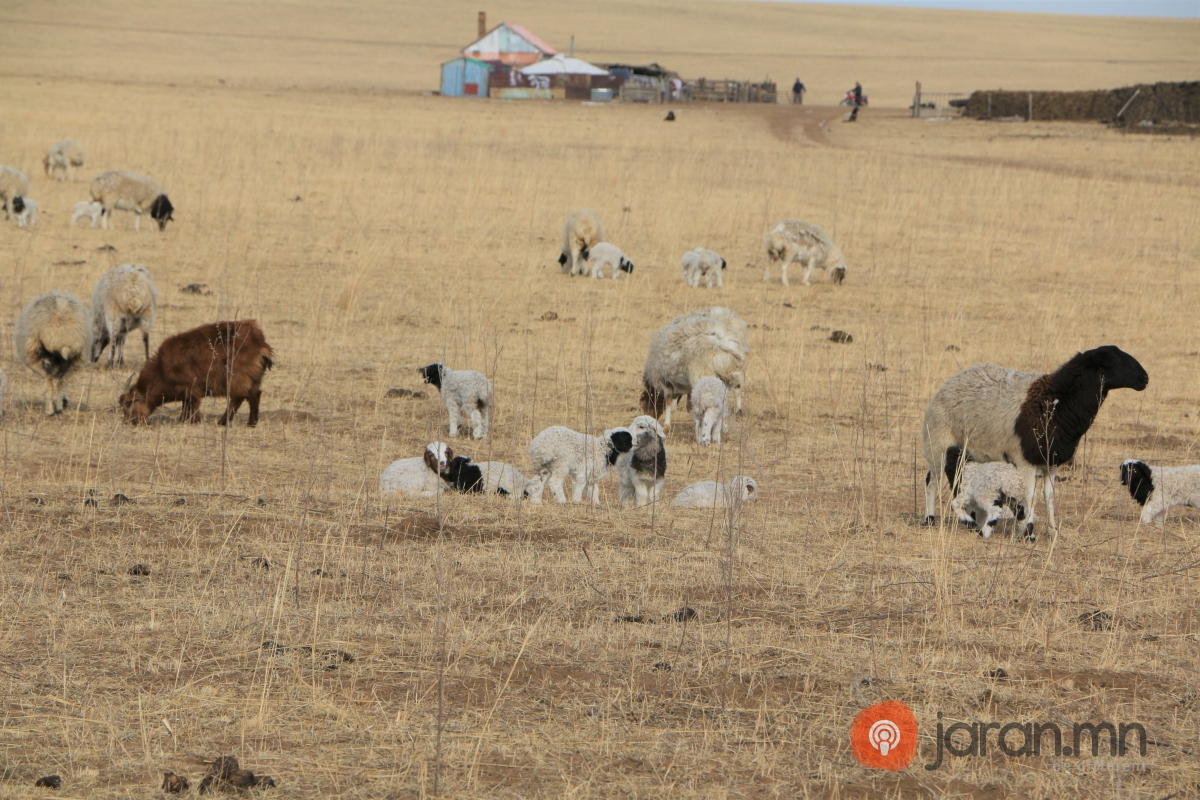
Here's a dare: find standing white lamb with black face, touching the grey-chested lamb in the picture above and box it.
[526,425,634,505]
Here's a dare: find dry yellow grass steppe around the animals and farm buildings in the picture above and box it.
[0,0,1200,800]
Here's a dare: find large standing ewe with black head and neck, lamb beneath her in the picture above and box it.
[922,344,1150,539]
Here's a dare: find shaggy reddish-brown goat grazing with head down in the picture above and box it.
[120,319,275,427]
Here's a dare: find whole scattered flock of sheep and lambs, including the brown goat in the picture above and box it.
[0,145,1180,532]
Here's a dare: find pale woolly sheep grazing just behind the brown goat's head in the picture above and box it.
[91,264,158,367]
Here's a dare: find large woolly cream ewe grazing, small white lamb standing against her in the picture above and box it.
[641,306,750,431]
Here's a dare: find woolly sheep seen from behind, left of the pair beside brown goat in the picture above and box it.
[13,291,91,416]
